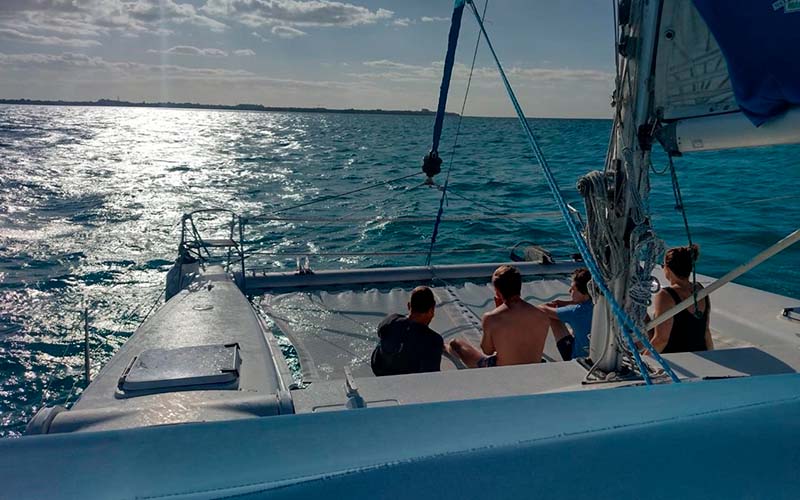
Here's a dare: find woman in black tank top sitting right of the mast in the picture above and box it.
[650,245,714,353]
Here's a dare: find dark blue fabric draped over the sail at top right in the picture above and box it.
[694,0,800,126]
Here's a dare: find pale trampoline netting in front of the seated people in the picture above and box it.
[262,277,569,382]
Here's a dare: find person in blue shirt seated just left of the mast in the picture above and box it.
[539,267,594,361]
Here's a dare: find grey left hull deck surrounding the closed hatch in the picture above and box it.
[51,269,291,432]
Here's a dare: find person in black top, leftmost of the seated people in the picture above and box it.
[371,286,444,377]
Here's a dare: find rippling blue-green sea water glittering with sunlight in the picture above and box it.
[0,106,800,437]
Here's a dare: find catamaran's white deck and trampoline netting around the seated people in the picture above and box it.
[250,263,800,413]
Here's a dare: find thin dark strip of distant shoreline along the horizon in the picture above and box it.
[0,99,458,116]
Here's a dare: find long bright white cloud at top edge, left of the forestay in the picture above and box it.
[200,0,394,27]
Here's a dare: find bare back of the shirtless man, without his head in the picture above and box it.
[481,297,549,366]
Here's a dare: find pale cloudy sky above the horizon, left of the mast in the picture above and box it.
[0,0,614,118]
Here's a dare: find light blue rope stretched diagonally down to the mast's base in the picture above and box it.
[467,0,680,385]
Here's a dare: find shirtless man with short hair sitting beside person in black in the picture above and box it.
[449,266,547,368]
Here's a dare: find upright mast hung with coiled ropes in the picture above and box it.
[579,0,663,372]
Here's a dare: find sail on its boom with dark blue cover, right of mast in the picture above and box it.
[653,0,800,154]
